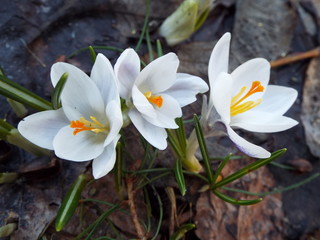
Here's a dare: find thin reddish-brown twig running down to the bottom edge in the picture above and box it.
[127,177,147,240]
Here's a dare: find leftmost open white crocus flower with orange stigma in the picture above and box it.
[18,54,122,178]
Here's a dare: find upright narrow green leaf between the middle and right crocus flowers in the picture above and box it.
[193,114,214,186]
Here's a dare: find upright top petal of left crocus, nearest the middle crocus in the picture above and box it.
[90,53,120,105]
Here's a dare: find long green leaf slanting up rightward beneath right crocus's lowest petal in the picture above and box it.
[213,148,287,188]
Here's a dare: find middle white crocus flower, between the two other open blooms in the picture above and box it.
[114,48,208,150]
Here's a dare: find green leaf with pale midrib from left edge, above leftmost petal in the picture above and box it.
[0,75,52,111]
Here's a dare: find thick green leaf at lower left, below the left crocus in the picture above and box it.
[55,174,89,232]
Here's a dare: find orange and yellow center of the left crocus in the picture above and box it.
[70,116,110,135]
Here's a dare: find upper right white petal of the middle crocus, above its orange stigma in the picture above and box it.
[135,53,179,93]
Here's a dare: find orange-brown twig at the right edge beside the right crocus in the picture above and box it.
[270,47,320,68]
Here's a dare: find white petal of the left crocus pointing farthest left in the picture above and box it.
[18,109,70,150]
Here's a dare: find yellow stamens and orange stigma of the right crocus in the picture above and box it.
[230,81,264,116]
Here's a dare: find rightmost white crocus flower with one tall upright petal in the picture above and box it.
[202,33,298,158]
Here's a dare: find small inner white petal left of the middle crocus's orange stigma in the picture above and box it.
[132,85,156,118]
